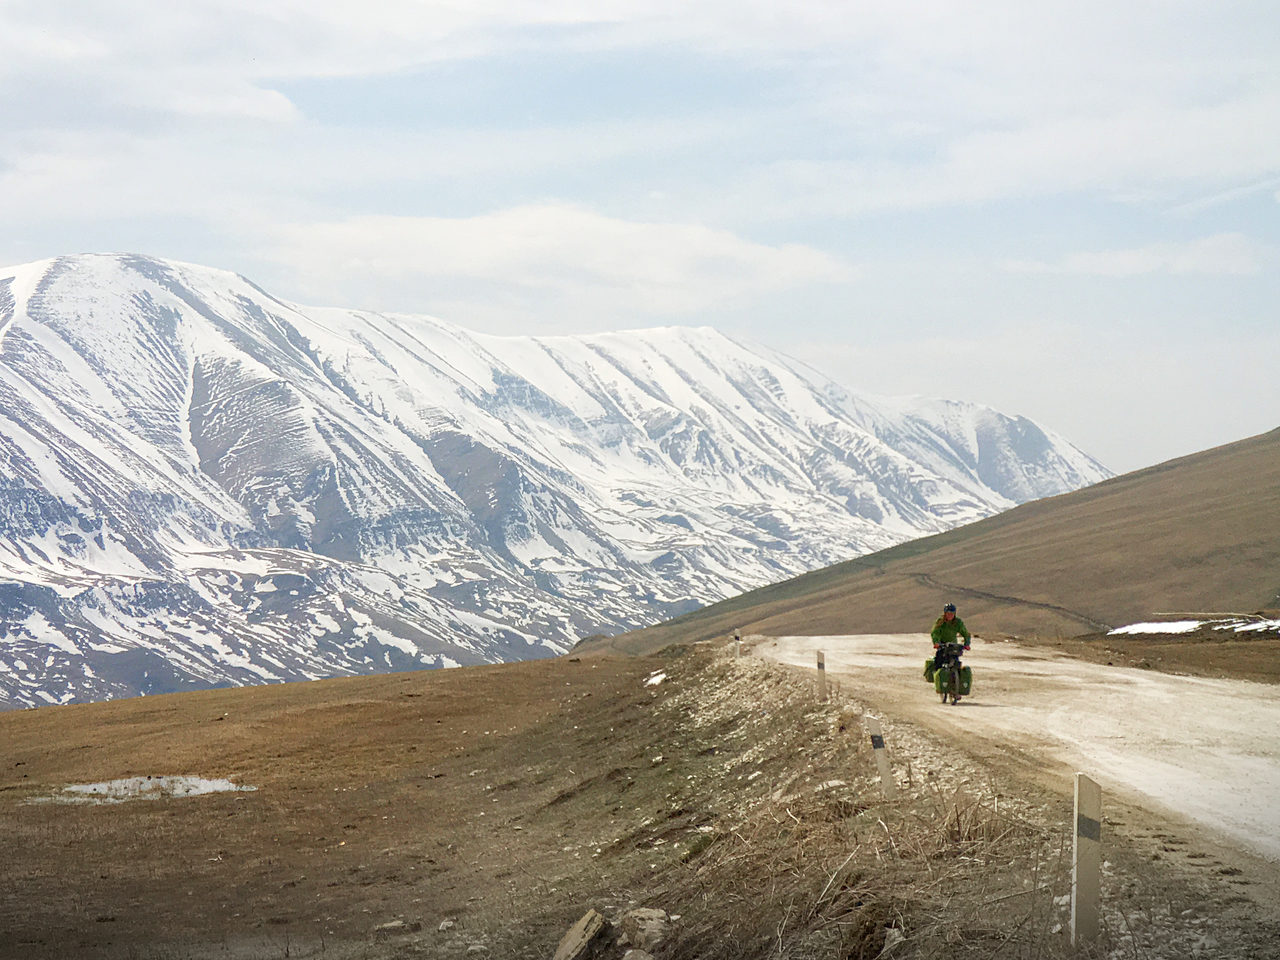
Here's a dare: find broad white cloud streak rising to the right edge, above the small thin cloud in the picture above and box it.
[709,87,1280,223]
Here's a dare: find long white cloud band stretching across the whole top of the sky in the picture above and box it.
[0,0,1276,127]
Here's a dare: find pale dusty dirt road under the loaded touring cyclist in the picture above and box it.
[755,634,1280,873]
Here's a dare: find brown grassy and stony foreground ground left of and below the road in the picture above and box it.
[0,645,1280,960]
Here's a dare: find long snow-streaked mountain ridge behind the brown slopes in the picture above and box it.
[0,256,1108,705]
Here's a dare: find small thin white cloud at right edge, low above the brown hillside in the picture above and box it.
[1002,233,1280,278]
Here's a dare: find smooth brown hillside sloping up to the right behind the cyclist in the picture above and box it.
[581,430,1280,653]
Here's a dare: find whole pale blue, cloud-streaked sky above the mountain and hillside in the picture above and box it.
[0,0,1280,471]
